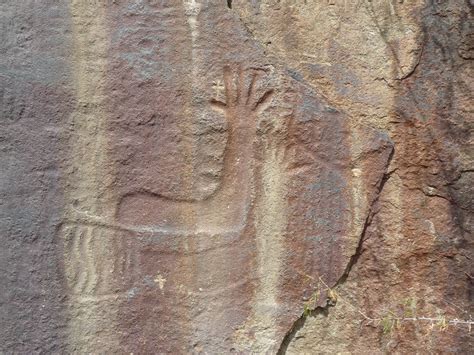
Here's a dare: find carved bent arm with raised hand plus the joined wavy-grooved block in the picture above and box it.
[58,66,274,297]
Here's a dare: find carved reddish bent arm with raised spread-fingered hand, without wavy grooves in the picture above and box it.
[116,66,273,234]
